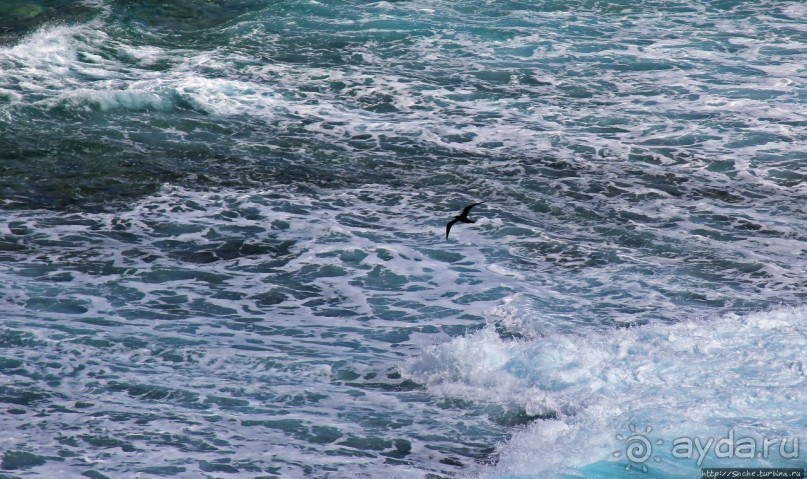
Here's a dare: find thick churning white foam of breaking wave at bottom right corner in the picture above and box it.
[407,307,807,477]
